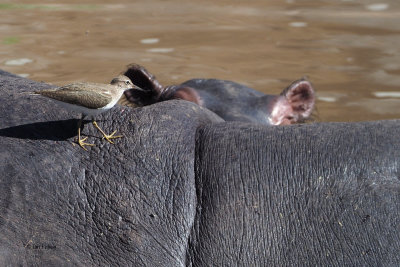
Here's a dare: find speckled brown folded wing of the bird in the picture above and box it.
[36,84,112,109]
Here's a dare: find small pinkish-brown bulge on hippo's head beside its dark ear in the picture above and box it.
[160,85,203,106]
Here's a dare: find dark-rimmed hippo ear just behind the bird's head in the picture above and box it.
[122,63,162,95]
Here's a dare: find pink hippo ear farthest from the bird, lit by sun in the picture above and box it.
[269,80,315,125]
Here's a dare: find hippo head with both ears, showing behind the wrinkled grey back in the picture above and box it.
[121,64,315,125]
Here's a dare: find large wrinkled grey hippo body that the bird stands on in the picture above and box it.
[0,71,400,266]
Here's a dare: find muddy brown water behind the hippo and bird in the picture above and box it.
[0,0,400,121]
